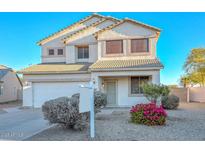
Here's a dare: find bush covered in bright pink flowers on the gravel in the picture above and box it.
[130,102,167,126]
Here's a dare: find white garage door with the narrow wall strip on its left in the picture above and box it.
[23,82,88,108]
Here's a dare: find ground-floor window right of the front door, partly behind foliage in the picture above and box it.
[131,76,149,94]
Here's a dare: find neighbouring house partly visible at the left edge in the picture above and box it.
[0,65,22,103]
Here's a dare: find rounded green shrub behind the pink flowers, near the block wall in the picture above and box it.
[161,95,179,110]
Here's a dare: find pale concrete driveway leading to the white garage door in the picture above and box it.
[0,107,50,140]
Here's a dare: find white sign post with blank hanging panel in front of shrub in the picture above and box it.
[79,81,95,138]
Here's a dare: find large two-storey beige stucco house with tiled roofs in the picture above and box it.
[20,14,163,107]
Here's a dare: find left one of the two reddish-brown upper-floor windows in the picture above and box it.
[106,40,123,54]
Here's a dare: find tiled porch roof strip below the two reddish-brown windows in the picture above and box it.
[90,59,163,70]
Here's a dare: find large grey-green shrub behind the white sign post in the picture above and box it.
[42,92,107,130]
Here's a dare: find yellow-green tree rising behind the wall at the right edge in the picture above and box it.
[181,48,205,86]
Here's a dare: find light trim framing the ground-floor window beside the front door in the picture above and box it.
[128,75,152,97]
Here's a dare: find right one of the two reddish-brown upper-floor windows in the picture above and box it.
[131,39,149,53]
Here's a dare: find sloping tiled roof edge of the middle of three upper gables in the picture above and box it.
[62,17,120,43]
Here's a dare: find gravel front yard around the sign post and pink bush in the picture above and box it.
[27,103,205,141]
